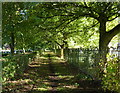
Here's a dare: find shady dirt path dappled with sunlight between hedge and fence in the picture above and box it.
[3,53,115,93]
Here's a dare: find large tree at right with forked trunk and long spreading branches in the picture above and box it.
[32,2,120,62]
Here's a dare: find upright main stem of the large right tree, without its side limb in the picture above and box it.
[99,17,109,78]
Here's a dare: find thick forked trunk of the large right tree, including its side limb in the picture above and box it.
[99,20,120,76]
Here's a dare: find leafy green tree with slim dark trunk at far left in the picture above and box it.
[2,2,41,55]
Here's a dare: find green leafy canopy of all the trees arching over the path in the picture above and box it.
[3,2,120,55]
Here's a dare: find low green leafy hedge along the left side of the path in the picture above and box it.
[2,53,35,82]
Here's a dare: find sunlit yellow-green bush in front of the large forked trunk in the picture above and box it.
[102,58,120,92]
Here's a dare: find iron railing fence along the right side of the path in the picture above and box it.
[56,48,119,79]
